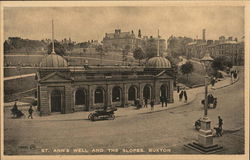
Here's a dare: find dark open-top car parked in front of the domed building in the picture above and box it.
[88,108,117,121]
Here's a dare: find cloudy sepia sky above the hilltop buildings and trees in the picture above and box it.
[4,6,244,42]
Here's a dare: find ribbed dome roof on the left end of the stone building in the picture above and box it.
[40,53,68,68]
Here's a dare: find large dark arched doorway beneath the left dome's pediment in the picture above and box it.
[51,90,62,112]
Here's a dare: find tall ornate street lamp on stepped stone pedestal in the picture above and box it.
[186,52,223,153]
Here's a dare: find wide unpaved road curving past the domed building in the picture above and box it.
[4,68,244,154]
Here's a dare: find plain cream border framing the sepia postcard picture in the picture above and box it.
[0,1,250,160]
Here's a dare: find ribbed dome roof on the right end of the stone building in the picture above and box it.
[146,56,171,68]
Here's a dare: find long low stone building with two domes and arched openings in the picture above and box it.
[37,53,174,115]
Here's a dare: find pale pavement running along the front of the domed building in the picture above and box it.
[4,72,238,119]
